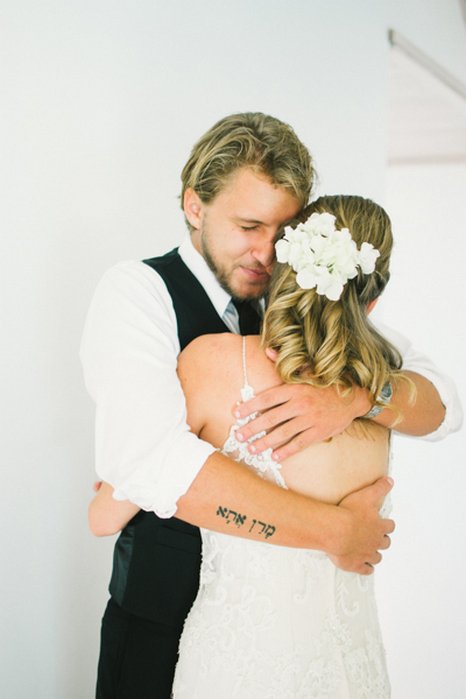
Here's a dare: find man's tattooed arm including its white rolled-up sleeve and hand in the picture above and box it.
[81,263,393,573]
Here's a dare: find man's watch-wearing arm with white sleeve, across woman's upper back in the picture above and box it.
[235,326,463,461]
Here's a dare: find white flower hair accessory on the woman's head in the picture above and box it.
[275,213,380,301]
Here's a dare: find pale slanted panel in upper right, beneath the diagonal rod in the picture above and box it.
[388,32,466,164]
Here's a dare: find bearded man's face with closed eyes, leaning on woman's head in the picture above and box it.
[185,169,300,299]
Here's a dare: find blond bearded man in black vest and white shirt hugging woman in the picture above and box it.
[81,113,452,699]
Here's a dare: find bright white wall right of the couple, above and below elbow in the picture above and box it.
[377,164,466,699]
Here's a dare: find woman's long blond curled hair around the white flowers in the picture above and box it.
[262,195,412,417]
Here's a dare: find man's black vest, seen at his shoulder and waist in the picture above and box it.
[109,249,233,627]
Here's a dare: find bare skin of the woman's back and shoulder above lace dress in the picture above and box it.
[178,333,389,503]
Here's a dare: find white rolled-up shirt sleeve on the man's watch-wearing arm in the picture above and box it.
[374,321,463,442]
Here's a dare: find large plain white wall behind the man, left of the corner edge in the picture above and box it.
[0,0,462,699]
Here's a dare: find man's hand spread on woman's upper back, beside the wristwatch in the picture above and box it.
[234,383,371,461]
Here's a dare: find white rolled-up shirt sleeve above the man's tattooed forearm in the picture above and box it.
[80,262,215,517]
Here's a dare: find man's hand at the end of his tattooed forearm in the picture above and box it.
[329,478,395,575]
